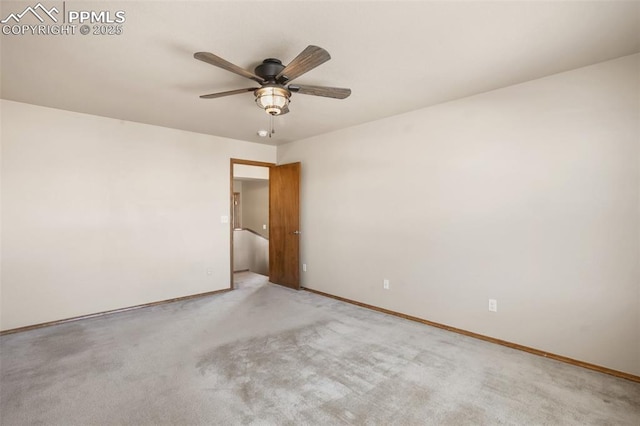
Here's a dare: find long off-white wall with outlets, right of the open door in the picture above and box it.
[278,55,640,375]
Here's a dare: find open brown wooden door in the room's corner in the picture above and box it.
[269,163,300,290]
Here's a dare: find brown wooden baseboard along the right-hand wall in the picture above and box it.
[302,287,640,383]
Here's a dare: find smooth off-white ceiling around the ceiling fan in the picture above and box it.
[0,0,640,145]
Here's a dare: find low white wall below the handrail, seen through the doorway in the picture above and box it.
[233,229,269,275]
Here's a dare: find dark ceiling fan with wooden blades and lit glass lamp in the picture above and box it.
[193,46,351,117]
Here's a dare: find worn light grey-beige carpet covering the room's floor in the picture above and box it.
[0,273,640,426]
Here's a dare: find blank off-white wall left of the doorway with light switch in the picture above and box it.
[0,100,276,330]
